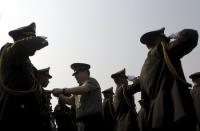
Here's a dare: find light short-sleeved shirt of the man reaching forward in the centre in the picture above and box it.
[75,78,102,118]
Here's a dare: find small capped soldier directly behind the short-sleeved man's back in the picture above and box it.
[102,87,114,131]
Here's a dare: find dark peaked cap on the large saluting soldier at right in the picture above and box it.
[140,27,165,44]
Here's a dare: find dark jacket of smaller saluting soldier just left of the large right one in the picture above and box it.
[113,80,140,131]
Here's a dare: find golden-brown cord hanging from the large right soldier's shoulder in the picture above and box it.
[161,41,191,87]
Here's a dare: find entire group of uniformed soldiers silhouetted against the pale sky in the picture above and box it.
[0,23,200,131]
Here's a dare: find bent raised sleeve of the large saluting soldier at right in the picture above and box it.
[168,29,198,58]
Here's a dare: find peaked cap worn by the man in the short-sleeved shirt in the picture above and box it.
[71,63,90,76]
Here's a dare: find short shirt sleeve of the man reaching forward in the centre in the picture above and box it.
[83,79,100,92]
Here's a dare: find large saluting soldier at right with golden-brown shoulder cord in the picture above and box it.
[139,28,198,131]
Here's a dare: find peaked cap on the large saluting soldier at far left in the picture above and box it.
[8,22,36,41]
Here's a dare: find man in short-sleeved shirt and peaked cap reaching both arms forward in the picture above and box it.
[53,63,103,131]
